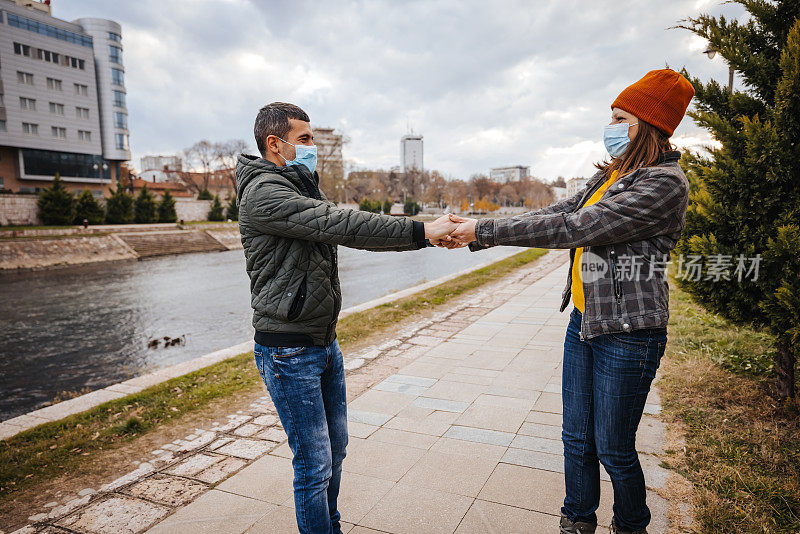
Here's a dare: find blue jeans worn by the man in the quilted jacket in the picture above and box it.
[253,341,347,534]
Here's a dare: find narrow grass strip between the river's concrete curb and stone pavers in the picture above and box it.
[0,249,546,500]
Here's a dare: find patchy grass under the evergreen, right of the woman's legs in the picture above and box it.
[661,284,800,534]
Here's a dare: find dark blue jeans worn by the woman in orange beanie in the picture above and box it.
[561,309,667,530]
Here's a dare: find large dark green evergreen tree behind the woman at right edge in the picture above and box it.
[677,0,800,399]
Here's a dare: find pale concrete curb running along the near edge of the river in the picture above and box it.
[0,250,536,440]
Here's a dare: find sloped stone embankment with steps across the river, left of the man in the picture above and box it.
[0,222,242,273]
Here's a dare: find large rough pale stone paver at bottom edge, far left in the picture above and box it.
[56,495,170,534]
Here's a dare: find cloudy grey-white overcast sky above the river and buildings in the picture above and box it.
[53,0,741,179]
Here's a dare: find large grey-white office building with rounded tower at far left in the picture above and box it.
[0,0,130,195]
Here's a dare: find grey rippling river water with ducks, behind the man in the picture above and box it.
[0,247,520,421]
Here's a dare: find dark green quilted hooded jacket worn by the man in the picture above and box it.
[236,154,426,347]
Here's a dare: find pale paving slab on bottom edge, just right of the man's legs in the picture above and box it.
[360,484,472,534]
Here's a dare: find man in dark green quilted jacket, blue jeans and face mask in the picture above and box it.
[236,102,457,534]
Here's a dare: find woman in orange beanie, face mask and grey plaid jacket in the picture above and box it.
[450,69,694,534]
